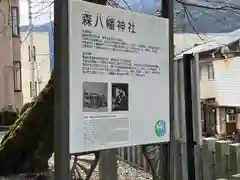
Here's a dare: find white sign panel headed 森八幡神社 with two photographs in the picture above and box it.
[69,1,169,153]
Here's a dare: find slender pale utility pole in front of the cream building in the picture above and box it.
[28,0,37,100]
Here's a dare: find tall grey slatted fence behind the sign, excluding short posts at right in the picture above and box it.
[115,56,202,180]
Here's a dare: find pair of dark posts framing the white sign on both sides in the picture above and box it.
[54,0,174,180]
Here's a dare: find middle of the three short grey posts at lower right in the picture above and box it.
[216,141,232,178]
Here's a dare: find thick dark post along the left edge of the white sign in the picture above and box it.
[53,0,70,180]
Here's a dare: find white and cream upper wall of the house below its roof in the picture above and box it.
[200,57,240,106]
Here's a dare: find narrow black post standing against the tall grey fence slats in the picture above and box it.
[183,54,196,180]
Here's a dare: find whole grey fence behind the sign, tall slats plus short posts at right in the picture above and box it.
[118,54,240,180]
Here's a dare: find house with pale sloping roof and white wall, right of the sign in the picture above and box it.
[176,30,240,135]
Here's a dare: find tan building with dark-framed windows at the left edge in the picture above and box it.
[0,0,23,111]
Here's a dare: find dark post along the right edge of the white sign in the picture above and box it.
[161,0,175,180]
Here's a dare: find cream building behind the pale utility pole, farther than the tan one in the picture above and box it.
[21,32,51,103]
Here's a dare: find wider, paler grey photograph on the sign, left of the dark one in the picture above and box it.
[83,82,108,112]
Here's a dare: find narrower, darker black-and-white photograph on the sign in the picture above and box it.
[112,83,128,111]
